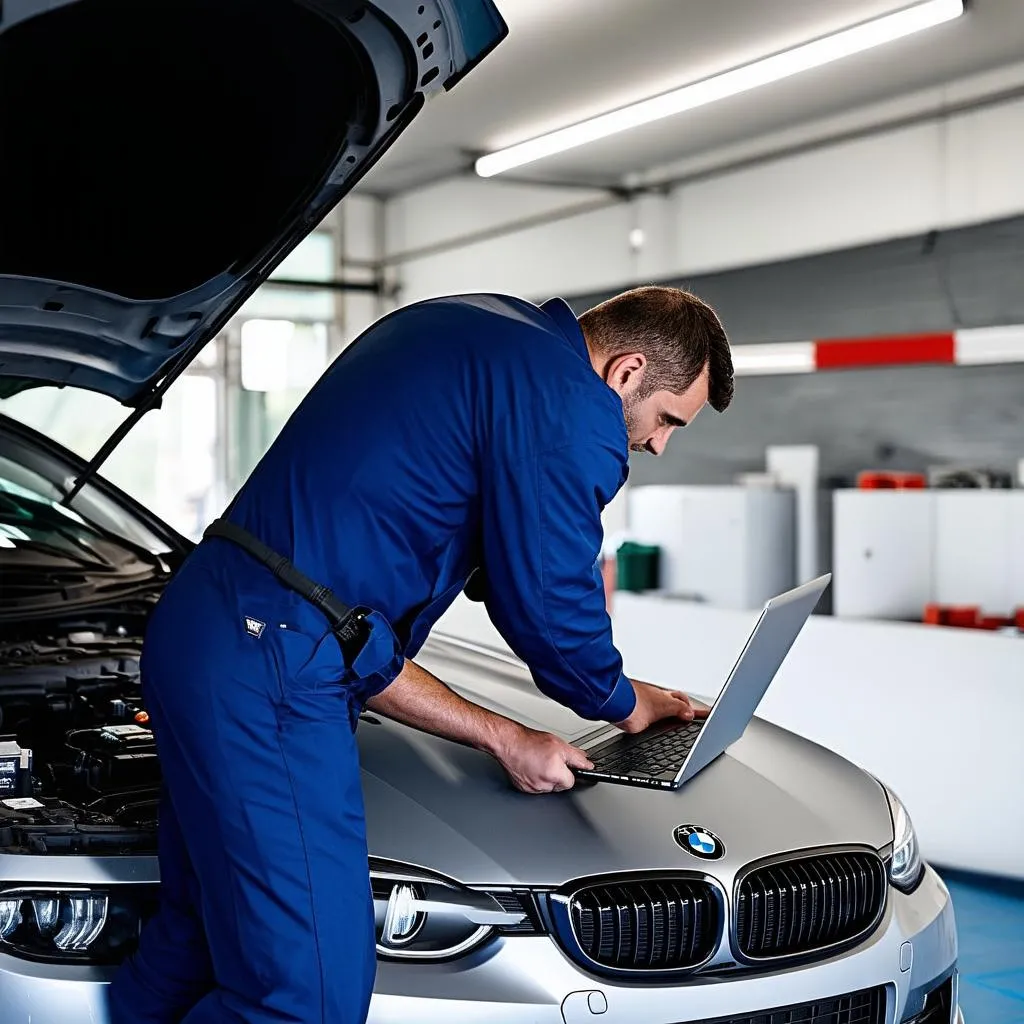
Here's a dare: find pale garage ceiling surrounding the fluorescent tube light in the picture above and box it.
[362,0,1024,195]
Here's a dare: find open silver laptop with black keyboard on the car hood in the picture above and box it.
[570,572,831,790]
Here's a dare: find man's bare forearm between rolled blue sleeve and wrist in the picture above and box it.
[367,660,522,757]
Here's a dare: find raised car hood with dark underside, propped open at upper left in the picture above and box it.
[0,0,507,406]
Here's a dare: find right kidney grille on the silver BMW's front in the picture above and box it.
[736,853,887,958]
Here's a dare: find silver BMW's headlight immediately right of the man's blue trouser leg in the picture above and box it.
[370,862,537,961]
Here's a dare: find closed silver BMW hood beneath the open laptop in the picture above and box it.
[357,641,893,886]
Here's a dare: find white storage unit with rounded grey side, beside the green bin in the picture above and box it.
[630,485,796,609]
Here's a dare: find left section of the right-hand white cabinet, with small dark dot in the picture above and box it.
[833,490,935,620]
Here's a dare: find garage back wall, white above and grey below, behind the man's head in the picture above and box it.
[368,63,1024,532]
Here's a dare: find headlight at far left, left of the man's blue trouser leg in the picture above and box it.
[0,886,155,964]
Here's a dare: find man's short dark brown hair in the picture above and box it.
[580,286,733,413]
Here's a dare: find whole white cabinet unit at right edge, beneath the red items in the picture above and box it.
[833,490,1024,620]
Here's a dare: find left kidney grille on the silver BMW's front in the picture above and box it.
[569,880,721,971]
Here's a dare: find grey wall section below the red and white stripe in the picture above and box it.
[630,366,1024,485]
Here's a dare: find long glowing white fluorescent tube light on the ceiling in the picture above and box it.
[476,0,964,178]
